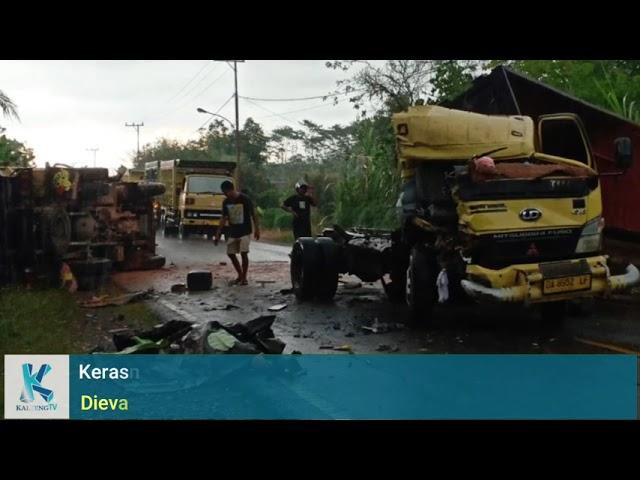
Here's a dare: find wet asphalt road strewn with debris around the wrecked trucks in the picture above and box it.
[115,232,640,355]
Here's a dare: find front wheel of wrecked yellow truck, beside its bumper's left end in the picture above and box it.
[406,247,438,323]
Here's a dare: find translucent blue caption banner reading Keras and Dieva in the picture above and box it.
[63,355,638,420]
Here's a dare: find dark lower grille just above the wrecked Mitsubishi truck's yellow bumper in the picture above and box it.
[471,228,581,268]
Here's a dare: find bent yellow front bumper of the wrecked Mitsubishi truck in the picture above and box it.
[460,256,640,304]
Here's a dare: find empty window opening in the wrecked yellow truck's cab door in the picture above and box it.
[538,113,594,168]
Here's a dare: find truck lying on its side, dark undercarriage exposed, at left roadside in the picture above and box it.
[0,165,165,290]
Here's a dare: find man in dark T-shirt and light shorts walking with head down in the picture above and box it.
[215,180,260,285]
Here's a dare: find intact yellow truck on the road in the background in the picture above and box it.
[145,159,237,239]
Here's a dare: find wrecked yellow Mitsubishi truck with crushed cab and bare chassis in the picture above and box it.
[291,106,640,321]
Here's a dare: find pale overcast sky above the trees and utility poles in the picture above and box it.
[0,60,372,169]
